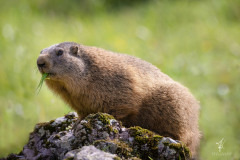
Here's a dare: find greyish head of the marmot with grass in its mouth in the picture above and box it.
[37,42,85,83]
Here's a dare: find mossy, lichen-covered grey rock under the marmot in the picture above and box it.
[1,112,191,160]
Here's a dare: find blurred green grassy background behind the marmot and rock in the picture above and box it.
[0,0,240,159]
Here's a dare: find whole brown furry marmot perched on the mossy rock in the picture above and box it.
[37,42,200,156]
